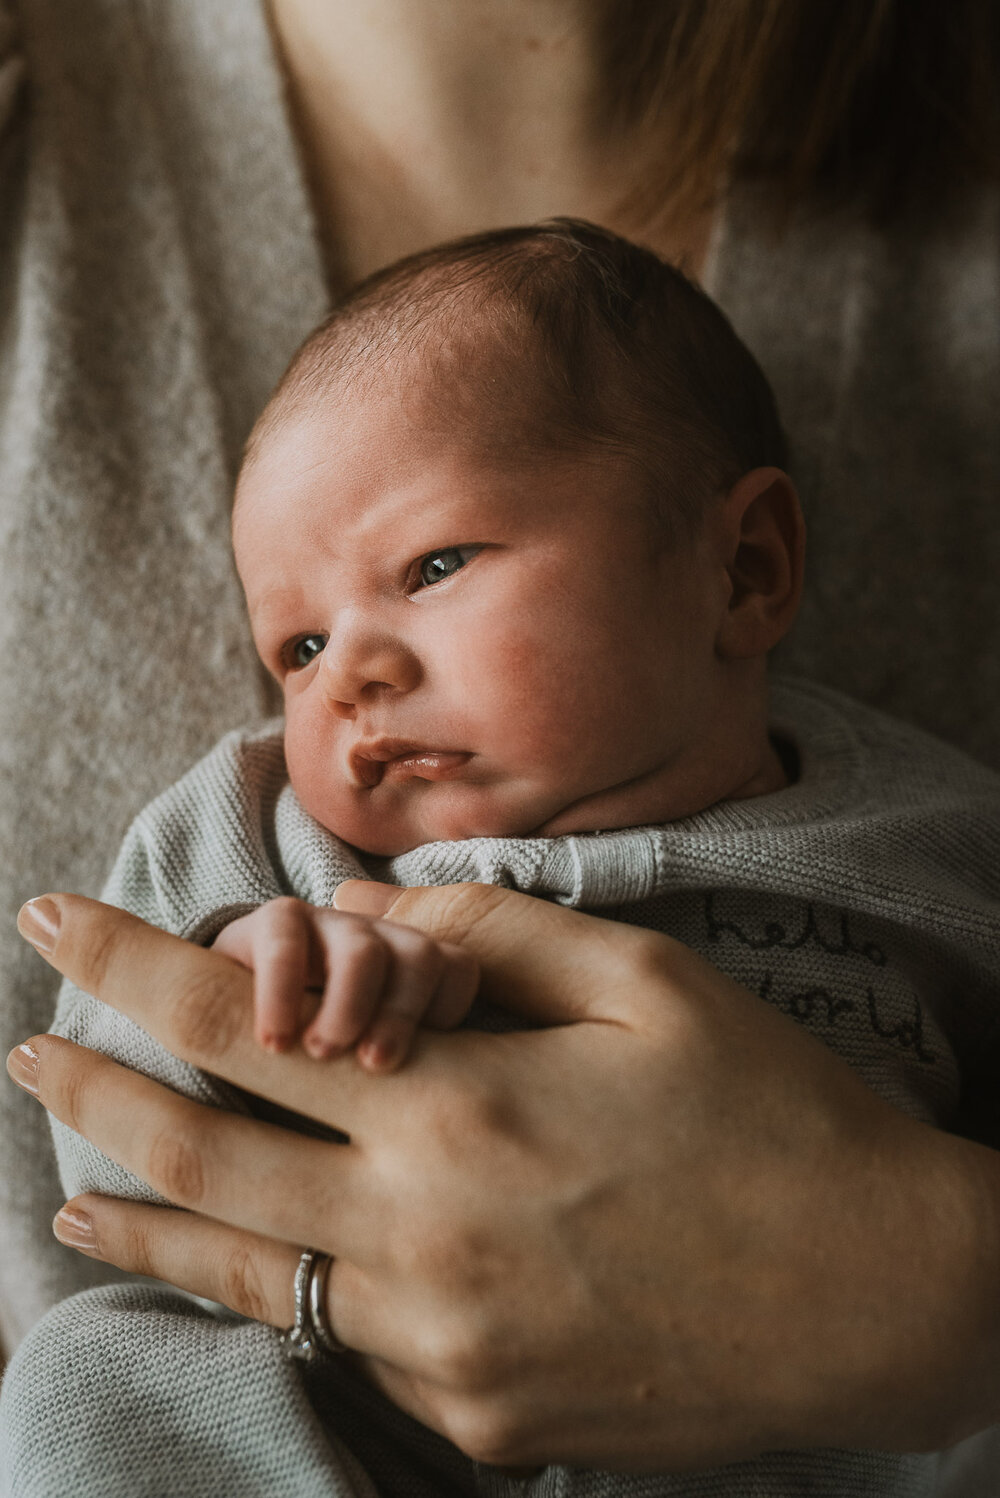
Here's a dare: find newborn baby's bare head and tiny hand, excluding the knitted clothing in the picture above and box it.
[217,217,802,1068]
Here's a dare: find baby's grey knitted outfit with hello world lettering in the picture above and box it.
[3,683,1000,1498]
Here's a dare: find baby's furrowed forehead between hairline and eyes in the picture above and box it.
[234,388,655,587]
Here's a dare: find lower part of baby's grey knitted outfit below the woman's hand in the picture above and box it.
[3,1285,931,1498]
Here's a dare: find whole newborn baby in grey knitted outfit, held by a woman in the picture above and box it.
[42,222,1000,1498]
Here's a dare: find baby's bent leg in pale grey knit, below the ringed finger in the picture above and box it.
[3,1285,376,1498]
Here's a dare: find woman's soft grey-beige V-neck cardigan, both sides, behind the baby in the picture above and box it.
[0,0,1000,1480]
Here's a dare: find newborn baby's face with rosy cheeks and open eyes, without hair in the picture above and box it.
[234,380,729,854]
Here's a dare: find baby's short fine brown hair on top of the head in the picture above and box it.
[246,219,786,535]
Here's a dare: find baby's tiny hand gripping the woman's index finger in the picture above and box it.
[213,899,479,1071]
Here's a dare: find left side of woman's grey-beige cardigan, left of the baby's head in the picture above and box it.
[0,0,326,1348]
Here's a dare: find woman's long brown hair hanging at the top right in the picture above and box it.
[597,0,1000,229]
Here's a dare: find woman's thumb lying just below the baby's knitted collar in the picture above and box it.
[327,879,640,1025]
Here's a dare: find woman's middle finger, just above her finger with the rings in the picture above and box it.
[9,1035,385,1261]
